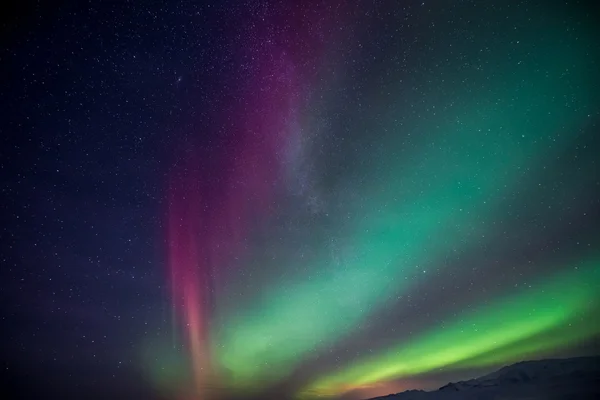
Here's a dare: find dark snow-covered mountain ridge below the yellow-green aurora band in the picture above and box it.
[371,357,600,400]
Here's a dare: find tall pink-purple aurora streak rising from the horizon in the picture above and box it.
[168,2,344,399]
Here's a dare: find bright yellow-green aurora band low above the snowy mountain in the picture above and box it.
[301,257,600,397]
